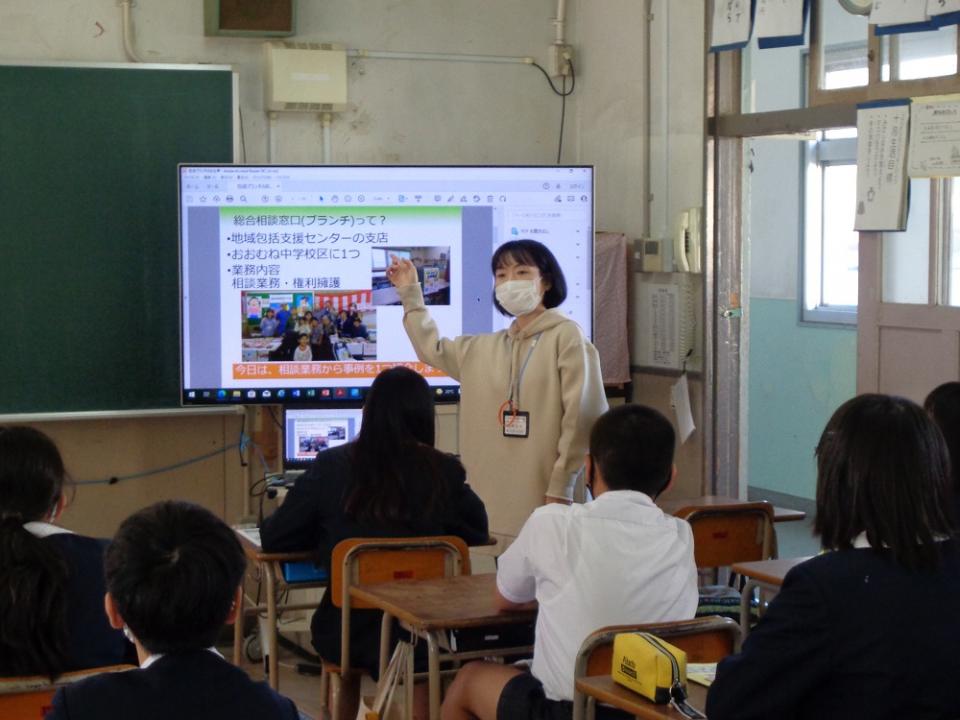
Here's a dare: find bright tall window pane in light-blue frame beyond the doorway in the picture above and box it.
[821,165,860,305]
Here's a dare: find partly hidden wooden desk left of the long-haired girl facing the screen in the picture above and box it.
[233,528,327,690]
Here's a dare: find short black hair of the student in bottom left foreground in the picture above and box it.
[104,500,246,654]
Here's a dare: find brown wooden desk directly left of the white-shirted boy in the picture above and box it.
[350,573,537,720]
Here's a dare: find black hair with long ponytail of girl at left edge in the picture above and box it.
[0,426,69,678]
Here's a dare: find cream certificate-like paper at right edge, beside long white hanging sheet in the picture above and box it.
[907,96,960,177]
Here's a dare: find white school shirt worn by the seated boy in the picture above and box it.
[497,490,699,700]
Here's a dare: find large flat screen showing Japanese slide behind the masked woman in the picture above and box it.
[179,165,593,405]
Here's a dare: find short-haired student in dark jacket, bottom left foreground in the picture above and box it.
[46,501,298,720]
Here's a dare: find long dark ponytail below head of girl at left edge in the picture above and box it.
[0,514,67,678]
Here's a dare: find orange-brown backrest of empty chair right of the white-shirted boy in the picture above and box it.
[676,500,777,568]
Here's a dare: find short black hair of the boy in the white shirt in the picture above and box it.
[590,404,676,498]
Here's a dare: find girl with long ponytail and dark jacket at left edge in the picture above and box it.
[0,427,134,678]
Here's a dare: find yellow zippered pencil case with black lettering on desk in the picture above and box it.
[612,632,687,704]
